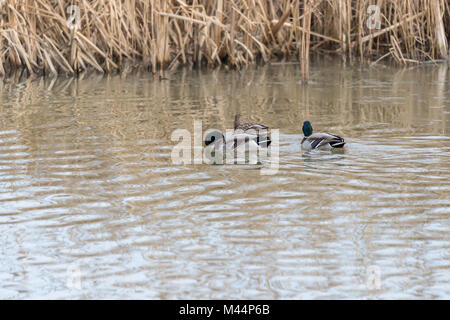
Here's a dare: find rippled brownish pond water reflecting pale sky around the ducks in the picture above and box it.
[0,61,450,299]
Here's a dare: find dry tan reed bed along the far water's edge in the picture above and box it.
[0,0,450,77]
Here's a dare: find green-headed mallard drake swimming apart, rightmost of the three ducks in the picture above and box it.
[302,121,345,150]
